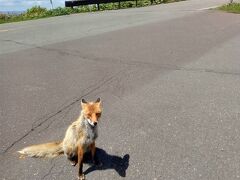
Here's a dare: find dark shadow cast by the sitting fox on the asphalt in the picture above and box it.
[84,148,130,177]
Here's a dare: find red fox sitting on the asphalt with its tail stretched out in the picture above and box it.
[18,98,102,180]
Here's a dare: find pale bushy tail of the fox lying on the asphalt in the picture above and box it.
[18,142,64,158]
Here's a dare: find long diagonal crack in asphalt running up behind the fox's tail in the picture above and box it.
[0,70,123,154]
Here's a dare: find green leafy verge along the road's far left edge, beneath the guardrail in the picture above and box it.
[0,0,183,24]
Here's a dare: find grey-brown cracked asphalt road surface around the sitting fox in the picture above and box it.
[0,0,240,180]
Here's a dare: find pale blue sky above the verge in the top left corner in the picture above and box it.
[0,0,65,11]
